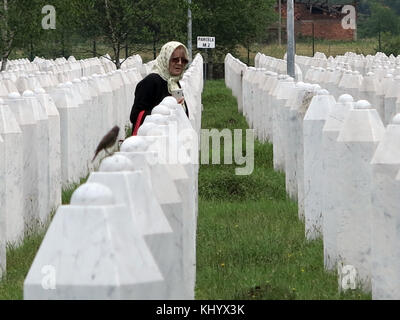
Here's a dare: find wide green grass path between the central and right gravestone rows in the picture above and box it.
[196,80,371,300]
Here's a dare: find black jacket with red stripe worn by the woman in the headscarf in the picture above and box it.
[130,73,189,131]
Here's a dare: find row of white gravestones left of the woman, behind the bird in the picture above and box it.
[0,54,145,280]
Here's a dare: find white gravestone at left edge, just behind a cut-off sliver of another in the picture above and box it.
[0,99,24,245]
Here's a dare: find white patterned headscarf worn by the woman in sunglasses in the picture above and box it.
[152,41,189,93]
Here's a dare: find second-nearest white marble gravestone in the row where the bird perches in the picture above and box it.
[88,155,187,300]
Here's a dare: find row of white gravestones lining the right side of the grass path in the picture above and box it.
[227,53,400,299]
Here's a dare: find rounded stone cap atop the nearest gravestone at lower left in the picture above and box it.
[71,183,115,206]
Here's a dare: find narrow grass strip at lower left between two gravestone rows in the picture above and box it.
[0,177,87,300]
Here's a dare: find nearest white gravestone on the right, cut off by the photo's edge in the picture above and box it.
[371,114,400,300]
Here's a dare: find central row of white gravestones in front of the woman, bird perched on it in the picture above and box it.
[24,56,202,300]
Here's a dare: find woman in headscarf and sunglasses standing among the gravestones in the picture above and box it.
[130,41,189,135]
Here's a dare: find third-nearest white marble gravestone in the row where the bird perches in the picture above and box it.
[118,136,197,299]
